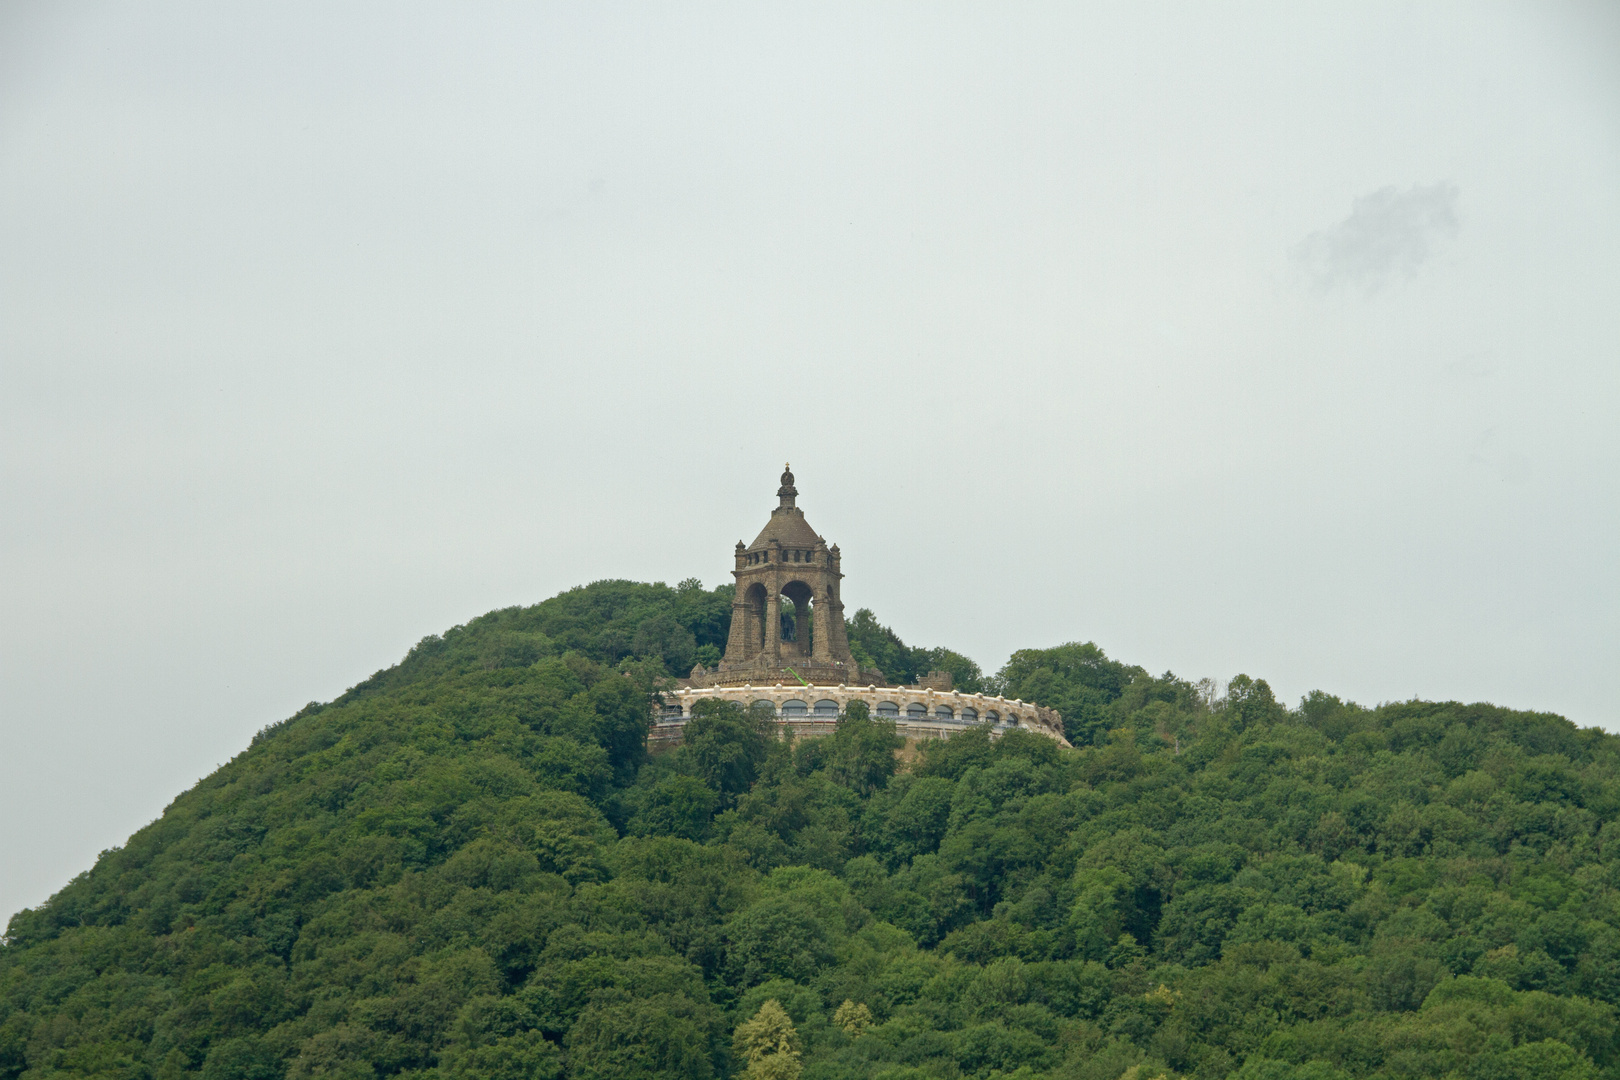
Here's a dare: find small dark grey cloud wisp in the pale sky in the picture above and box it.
[1294,183,1458,291]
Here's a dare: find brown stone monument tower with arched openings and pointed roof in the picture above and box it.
[716,466,860,685]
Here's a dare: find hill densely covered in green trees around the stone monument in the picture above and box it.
[0,581,1620,1080]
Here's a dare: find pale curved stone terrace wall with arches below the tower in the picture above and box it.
[651,683,1069,746]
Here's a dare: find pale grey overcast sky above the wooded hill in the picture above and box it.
[0,0,1620,918]
